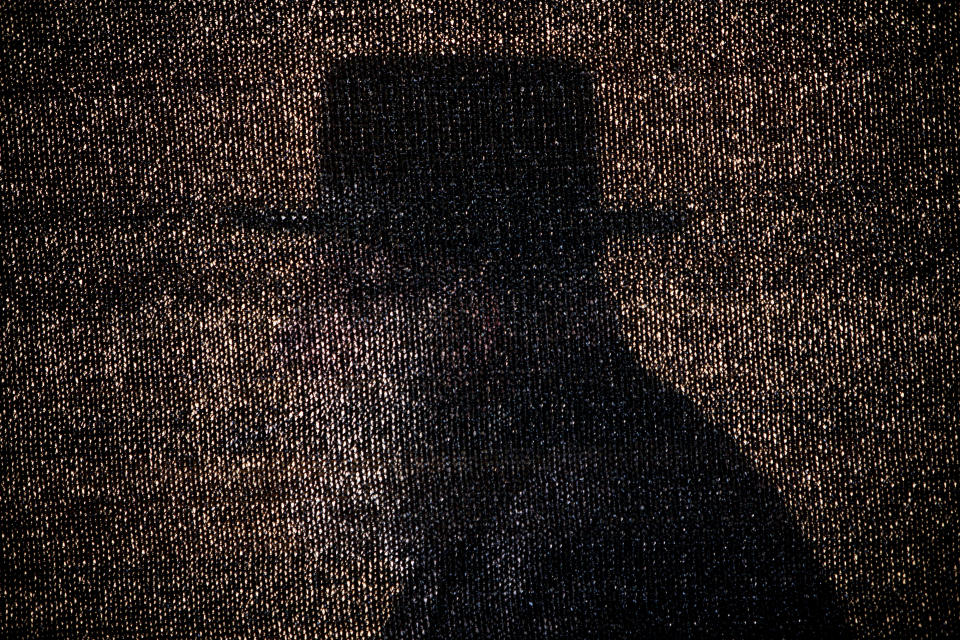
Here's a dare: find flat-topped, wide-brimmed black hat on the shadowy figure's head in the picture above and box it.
[232,56,684,266]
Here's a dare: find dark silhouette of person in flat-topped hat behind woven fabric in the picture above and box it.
[232,58,842,638]
